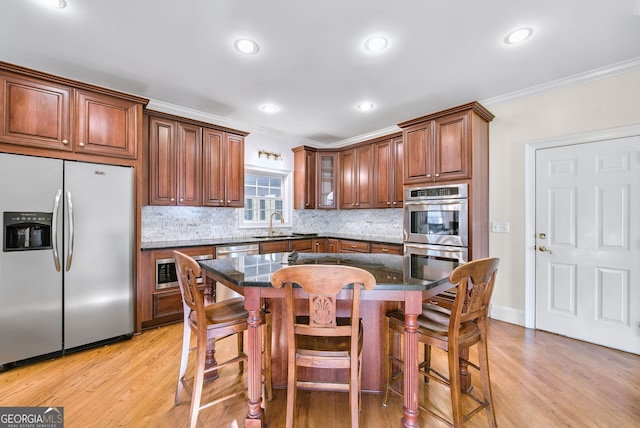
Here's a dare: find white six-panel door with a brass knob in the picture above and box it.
[535,137,640,354]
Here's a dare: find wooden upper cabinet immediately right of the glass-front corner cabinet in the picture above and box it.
[339,144,373,209]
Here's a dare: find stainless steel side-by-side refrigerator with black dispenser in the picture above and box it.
[0,153,134,368]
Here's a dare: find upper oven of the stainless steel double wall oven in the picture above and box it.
[403,184,469,247]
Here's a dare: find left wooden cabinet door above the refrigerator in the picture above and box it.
[0,73,73,151]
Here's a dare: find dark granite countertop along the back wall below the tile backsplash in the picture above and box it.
[141,232,402,251]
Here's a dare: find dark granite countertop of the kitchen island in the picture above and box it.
[198,253,451,291]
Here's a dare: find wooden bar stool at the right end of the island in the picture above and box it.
[383,258,499,427]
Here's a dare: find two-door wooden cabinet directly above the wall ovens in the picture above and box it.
[398,102,493,184]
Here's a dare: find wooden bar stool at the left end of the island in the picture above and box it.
[173,251,273,428]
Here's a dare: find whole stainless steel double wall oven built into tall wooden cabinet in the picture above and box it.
[403,183,469,281]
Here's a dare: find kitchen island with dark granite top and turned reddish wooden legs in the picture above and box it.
[199,253,453,427]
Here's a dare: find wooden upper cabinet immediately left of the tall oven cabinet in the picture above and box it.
[373,137,404,208]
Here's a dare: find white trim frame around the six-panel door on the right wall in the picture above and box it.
[524,125,640,328]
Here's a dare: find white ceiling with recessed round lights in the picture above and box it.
[0,0,640,146]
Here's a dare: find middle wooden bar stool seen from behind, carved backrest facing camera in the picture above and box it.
[271,265,376,428]
